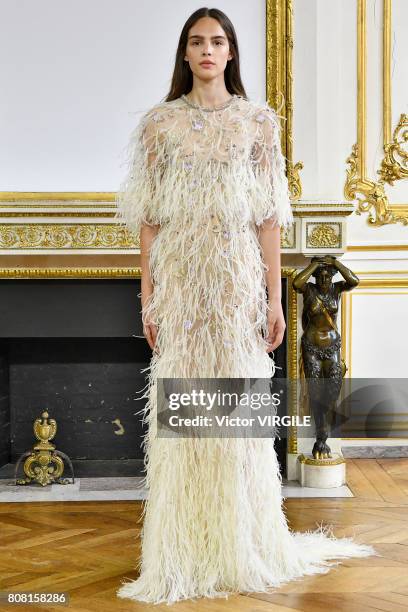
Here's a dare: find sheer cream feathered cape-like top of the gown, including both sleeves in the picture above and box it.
[117,96,293,233]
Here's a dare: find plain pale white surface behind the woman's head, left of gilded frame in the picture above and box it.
[0,0,265,192]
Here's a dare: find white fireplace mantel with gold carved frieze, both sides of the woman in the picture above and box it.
[0,192,354,266]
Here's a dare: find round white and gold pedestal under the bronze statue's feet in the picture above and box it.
[298,453,346,489]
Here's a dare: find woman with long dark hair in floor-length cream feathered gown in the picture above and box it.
[113,8,371,603]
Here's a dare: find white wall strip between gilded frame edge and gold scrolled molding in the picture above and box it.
[293,0,357,202]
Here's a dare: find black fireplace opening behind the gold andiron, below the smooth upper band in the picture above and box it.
[0,338,151,478]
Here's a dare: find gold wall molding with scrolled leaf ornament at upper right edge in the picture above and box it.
[344,0,408,226]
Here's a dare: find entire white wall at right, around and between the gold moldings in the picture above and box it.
[293,0,408,244]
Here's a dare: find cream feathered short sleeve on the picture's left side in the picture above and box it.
[115,109,166,238]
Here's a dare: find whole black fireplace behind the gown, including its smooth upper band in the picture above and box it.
[0,277,287,478]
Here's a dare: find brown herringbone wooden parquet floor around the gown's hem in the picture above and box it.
[0,458,408,612]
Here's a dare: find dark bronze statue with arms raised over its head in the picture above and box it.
[293,255,359,459]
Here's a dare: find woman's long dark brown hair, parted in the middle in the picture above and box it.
[165,7,247,102]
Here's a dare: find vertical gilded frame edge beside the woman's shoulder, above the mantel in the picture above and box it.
[266,0,303,200]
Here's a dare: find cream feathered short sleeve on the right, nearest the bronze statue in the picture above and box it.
[251,104,294,228]
